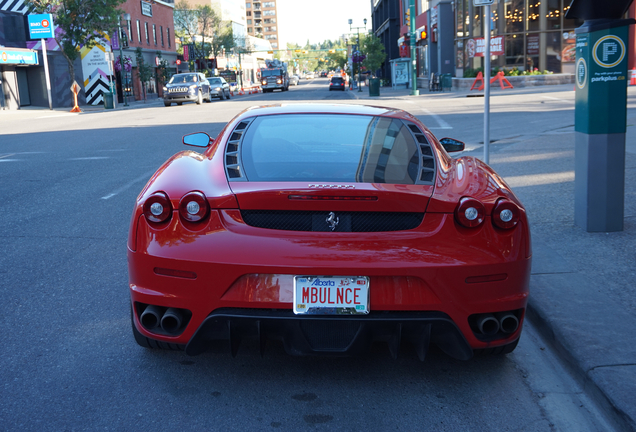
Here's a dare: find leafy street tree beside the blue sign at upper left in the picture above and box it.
[25,0,125,102]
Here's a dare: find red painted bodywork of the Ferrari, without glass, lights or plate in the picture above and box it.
[128,104,531,358]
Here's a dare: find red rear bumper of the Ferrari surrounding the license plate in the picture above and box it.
[128,210,531,357]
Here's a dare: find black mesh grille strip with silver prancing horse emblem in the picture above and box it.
[241,210,424,232]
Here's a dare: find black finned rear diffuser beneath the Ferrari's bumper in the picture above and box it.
[186,309,473,360]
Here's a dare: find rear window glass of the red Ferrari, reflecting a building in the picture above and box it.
[241,114,420,184]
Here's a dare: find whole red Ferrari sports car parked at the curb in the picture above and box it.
[128,104,532,359]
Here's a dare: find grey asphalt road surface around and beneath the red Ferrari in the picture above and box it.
[0,79,611,431]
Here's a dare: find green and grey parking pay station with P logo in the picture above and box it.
[566,0,636,232]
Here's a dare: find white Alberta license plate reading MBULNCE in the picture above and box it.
[294,276,369,315]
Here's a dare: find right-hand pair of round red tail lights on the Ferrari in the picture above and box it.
[455,197,520,229]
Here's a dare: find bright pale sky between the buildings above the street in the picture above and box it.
[276,0,371,48]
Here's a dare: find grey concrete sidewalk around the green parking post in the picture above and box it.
[350,85,636,430]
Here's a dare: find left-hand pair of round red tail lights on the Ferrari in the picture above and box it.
[143,191,210,224]
